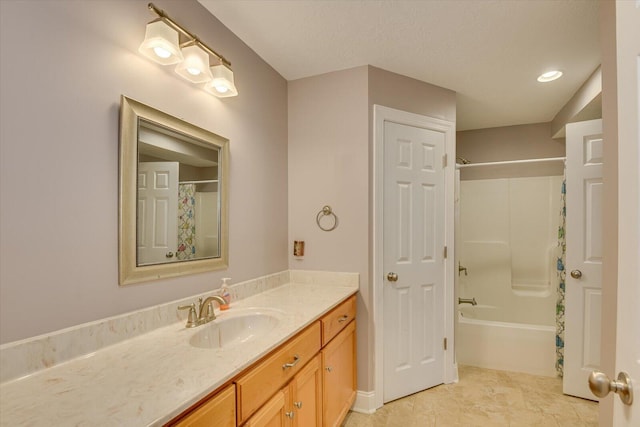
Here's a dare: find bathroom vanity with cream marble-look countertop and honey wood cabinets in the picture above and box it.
[0,271,358,427]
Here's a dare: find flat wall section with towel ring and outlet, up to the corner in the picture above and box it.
[289,66,371,390]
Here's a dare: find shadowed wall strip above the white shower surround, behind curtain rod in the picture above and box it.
[456,123,565,179]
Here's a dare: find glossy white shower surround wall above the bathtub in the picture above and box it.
[458,177,562,325]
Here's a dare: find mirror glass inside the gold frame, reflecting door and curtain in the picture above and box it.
[137,119,220,265]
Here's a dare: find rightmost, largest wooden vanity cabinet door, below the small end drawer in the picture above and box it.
[322,322,356,427]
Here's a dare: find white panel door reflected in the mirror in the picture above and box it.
[137,162,178,265]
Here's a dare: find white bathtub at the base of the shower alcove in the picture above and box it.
[455,305,556,377]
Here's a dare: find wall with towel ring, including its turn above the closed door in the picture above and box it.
[289,66,455,391]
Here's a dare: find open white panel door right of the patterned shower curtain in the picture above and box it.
[563,119,603,400]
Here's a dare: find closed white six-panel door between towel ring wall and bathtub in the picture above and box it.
[383,122,445,402]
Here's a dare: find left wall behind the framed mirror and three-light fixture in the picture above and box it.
[0,0,288,343]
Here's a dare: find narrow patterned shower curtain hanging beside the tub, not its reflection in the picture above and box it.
[556,174,567,377]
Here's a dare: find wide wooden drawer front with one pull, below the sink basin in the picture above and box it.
[236,322,321,425]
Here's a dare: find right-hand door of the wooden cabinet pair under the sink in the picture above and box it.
[290,354,322,427]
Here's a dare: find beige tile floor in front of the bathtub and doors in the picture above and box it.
[343,366,598,427]
